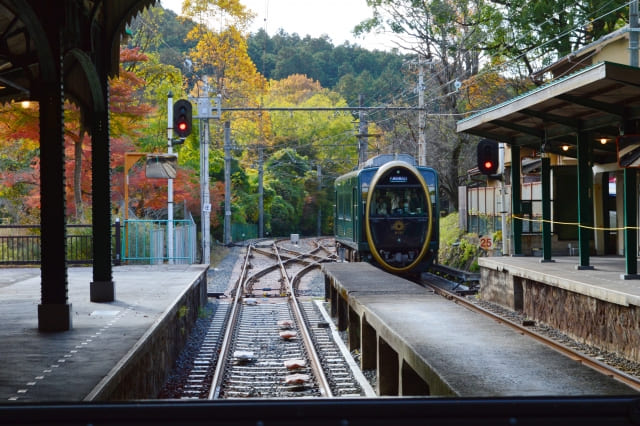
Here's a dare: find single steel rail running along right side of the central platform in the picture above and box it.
[422,282,640,391]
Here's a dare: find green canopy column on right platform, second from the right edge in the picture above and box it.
[576,132,593,269]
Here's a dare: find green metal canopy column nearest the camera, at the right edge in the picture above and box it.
[620,168,640,280]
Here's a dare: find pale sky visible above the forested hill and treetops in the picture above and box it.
[161,0,395,50]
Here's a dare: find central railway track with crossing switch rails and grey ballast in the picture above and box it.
[172,240,375,399]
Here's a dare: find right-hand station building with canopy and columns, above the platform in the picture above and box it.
[457,26,640,276]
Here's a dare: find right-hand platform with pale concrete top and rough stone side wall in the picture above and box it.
[478,256,640,362]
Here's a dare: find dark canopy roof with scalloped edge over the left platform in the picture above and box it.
[0,0,158,107]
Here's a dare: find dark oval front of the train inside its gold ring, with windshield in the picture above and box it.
[368,168,430,267]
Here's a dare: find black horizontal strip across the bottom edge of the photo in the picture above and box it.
[0,398,640,426]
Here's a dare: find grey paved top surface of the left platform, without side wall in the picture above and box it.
[0,265,207,404]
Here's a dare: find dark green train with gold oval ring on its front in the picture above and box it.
[335,154,439,274]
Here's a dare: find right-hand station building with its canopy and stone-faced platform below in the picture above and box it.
[457,27,640,362]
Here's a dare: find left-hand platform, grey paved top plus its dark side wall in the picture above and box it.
[0,265,207,404]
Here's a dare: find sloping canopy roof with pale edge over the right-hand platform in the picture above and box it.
[457,62,640,163]
